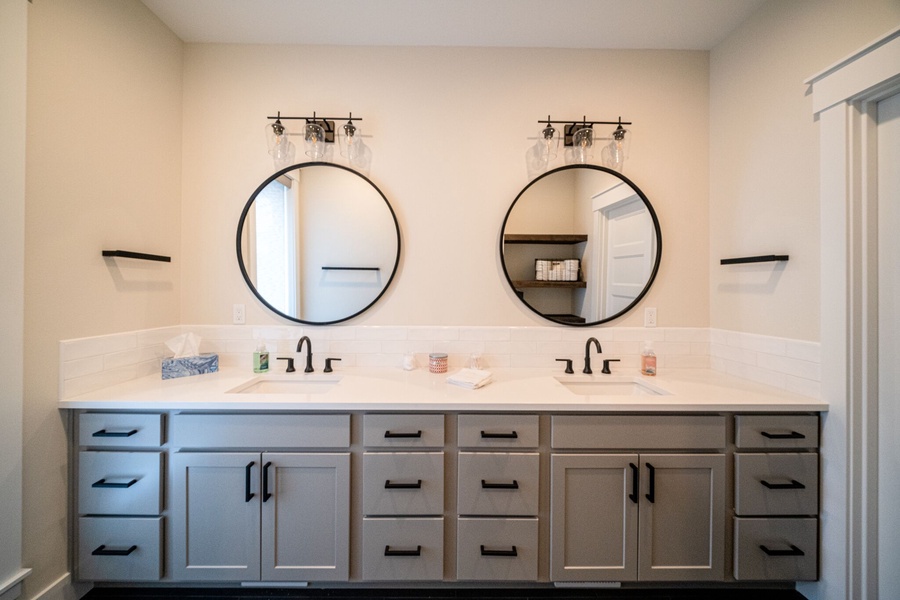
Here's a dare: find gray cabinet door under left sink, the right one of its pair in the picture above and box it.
[262,452,350,581]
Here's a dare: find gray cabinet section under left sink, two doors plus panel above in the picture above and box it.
[169,413,350,581]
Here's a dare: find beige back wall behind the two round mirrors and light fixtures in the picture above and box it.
[182,44,709,326]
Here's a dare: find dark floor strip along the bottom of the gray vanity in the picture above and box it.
[83,588,806,600]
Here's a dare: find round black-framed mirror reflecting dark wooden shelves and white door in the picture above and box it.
[500,164,662,326]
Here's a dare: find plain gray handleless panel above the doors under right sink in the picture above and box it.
[550,415,726,450]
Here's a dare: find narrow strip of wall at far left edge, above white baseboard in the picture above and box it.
[0,2,27,590]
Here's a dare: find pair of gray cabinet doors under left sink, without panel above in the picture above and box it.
[172,452,350,581]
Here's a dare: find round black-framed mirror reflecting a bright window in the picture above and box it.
[237,162,400,325]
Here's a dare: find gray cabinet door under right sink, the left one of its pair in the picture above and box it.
[550,454,640,581]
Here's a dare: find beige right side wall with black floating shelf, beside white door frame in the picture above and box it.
[709,0,900,341]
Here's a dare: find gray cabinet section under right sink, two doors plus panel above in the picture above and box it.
[550,416,726,582]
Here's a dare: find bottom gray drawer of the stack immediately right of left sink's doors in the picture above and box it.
[362,518,444,581]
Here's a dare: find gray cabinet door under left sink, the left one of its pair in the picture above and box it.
[171,452,260,581]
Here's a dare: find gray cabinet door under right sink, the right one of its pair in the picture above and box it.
[638,454,725,581]
